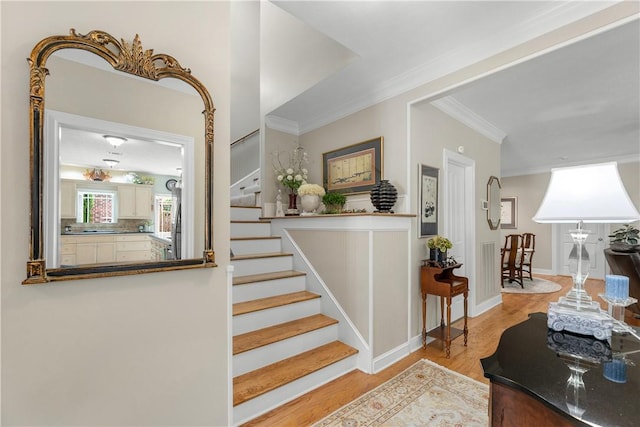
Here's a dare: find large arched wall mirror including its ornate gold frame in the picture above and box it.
[23,29,216,284]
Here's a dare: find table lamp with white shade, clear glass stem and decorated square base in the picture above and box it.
[533,162,640,339]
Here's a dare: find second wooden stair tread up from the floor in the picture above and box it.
[233,314,338,355]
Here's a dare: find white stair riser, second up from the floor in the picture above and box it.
[233,324,338,377]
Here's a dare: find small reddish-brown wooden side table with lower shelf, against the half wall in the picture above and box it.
[420,260,469,358]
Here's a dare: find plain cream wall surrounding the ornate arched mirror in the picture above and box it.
[0,2,230,426]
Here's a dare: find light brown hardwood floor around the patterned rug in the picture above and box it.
[244,275,640,427]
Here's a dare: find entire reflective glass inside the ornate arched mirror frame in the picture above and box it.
[43,49,204,268]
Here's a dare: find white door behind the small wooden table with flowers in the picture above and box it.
[440,152,474,320]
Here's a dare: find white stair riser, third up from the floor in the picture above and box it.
[233,298,320,336]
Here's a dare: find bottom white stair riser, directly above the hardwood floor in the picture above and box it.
[233,356,356,425]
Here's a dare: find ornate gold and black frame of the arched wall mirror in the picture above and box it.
[22,29,216,284]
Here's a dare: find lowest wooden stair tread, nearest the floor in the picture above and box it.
[233,341,358,406]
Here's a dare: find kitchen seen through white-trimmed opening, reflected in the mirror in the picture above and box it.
[51,111,192,267]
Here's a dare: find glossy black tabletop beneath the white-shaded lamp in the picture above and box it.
[481,313,640,426]
